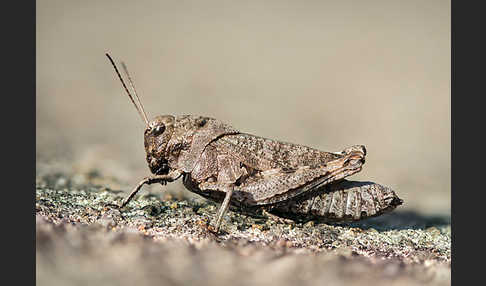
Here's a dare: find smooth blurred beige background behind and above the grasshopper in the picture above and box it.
[36,0,451,215]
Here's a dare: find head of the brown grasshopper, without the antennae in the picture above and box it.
[144,115,175,175]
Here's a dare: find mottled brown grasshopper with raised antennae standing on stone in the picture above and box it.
[106,54,402,232]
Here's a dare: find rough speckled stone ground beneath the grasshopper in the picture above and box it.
[36,168,451,286]
